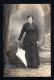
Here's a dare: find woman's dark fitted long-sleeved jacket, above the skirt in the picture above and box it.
[18,22,39,45]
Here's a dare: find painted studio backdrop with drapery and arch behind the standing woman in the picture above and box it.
[3,4,51,65]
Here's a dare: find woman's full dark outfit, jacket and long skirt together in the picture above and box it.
[18,22,40,68]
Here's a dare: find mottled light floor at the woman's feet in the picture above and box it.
[4,63,51,77]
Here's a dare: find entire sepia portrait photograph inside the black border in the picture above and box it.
[3,4,51,77]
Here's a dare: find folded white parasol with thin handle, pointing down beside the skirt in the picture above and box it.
[16,45,27,67]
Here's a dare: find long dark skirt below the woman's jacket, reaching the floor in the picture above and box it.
[24,45,40,68]
